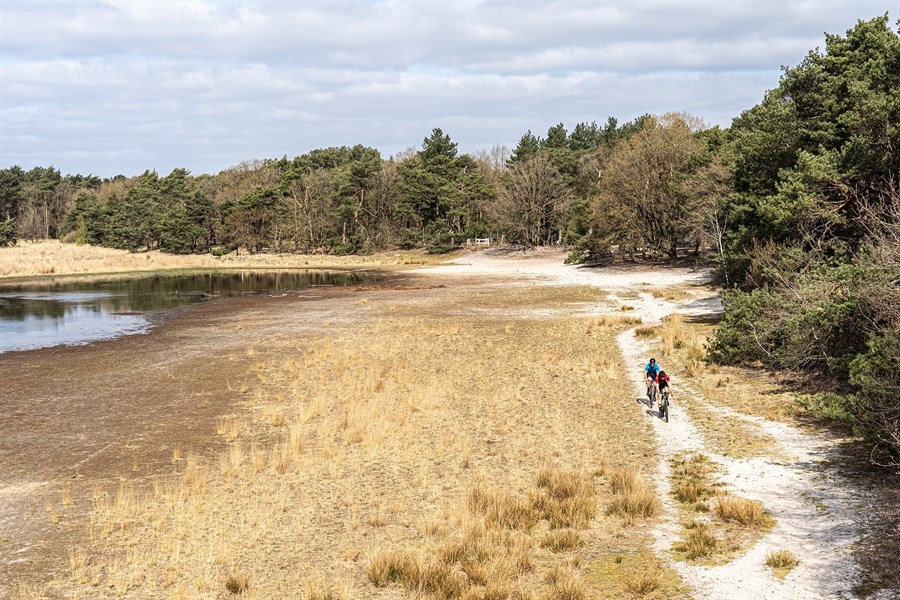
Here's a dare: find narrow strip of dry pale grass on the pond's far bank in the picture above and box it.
[0,240,447,277]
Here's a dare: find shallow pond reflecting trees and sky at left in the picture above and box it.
[0,270,372,353]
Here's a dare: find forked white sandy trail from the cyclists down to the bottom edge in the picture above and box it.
[618,330,862,599]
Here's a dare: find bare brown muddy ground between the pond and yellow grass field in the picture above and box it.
[0,288,380,584]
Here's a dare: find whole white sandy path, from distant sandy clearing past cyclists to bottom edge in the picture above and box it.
[423,246,863,600]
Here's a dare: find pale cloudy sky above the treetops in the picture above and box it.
[0,0,900,177]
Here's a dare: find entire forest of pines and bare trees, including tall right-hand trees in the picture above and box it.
[0,15,900,463]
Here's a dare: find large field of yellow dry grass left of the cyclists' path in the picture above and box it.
[31,286,668,598]
